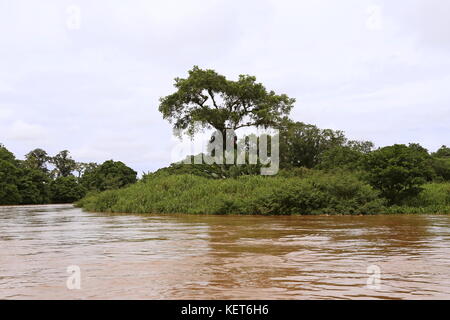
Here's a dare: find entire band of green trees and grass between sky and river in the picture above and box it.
[0,67,450,215]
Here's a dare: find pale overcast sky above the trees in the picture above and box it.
[0,0,450,172]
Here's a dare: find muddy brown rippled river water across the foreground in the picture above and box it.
[0,206,450,299]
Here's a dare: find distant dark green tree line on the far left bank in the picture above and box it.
[0,144,137,205]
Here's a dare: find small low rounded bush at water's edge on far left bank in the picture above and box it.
[50,176,86,203]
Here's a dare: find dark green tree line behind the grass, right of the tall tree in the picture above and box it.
[280,121,450,205]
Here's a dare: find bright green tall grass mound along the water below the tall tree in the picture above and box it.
[78,173,383,215]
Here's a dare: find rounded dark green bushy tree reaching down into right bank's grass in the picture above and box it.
[364,145,433,205]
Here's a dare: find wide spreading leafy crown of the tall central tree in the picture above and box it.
[159,66,295,138]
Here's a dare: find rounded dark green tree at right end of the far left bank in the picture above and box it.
[80,160,137,191]
